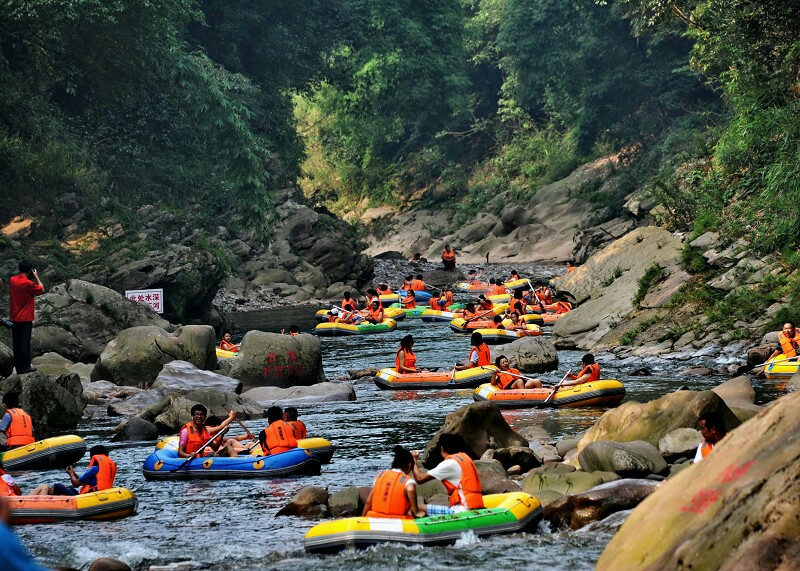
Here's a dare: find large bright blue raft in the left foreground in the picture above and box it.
[142,447,320,480]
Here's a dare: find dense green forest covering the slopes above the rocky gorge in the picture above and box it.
[0,0,800,322]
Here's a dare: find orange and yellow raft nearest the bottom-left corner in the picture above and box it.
[6,488,138,525]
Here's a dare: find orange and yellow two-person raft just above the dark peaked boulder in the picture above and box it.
[472,379,625,408]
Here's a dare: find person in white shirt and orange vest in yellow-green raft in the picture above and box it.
[411,433,483,515]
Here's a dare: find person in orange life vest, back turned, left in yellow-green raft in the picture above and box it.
[361,446,425,518]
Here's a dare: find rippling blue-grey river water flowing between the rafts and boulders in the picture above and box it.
[10,302,774,571]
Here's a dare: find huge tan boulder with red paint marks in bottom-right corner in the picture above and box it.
[597,393,800,571]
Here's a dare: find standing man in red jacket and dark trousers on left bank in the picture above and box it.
[8,260,44,375]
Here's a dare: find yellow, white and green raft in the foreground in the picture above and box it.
[304,492,542,553]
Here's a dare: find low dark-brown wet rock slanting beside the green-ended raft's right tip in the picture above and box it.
[544,479,658,529]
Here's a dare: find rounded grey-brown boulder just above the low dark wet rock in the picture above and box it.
[578,440,667,478]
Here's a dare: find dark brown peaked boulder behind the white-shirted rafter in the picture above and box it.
[422,402,528,469]
